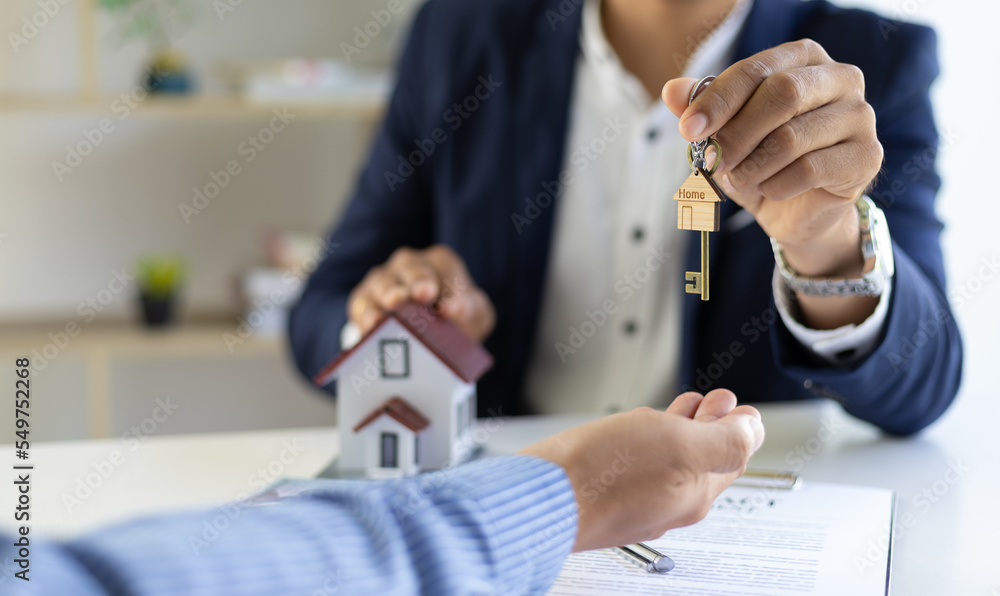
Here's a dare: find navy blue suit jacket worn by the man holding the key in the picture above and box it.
[290,0,962,434]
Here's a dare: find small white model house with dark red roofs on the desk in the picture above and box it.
[315,302,493,478]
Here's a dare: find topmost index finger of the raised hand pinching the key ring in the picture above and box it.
[680,39,830,142]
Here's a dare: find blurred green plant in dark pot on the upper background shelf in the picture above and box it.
[98,0,199,93]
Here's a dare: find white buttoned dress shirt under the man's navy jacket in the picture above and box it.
[527,0,889,413]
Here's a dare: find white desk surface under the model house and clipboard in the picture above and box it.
[0,401,1000,596]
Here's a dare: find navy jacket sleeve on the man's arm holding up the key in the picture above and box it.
[771,21,962,435]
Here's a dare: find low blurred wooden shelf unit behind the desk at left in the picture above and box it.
[0,320,336,441]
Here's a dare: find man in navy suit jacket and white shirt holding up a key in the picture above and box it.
[290,0,962,434]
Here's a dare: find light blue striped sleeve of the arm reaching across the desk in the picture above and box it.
[0,456,577,596]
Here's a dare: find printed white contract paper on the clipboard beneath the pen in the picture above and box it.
[549,482,893,596]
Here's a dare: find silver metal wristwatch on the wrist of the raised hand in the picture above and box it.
[771,196,895,296]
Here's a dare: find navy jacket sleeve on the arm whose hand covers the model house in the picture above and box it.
[289,2,440,378]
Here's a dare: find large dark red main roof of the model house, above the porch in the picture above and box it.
[313,302,493,387]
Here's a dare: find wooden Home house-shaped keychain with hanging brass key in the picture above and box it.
[674,76,726,300]
